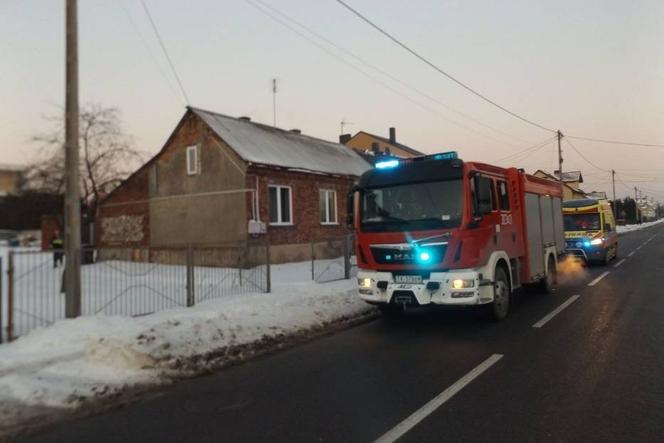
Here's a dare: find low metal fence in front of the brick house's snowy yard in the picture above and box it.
[0,243,270,340]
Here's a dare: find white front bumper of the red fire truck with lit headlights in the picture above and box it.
[357,269,493,306]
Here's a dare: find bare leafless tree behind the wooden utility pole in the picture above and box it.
[26,103,144,212]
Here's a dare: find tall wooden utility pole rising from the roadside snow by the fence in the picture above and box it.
[64,0,81,318]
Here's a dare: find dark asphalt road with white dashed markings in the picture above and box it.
[19,227,664,443]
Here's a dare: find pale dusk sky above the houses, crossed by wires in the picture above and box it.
[0,0,664,202]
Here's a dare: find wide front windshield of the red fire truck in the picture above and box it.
[362,180,463,231]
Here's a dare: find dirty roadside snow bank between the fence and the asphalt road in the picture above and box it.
[0,264,371,429]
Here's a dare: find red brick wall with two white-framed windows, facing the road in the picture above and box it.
[247,166,354,245]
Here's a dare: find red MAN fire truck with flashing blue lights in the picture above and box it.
[349,152,565,320]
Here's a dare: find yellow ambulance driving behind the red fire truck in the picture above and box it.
[563,198,618,265]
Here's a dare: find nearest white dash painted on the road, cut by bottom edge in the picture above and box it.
[376,354,503,443]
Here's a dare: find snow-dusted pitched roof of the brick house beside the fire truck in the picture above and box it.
[188,107,371,176]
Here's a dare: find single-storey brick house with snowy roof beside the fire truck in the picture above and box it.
[97,107,370,262]
